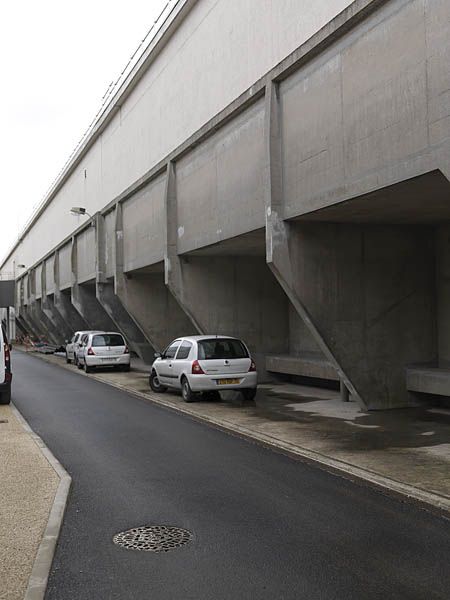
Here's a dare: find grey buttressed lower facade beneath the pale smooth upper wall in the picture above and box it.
[2,0,450,409]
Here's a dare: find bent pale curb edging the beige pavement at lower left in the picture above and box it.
[11,404,72,600]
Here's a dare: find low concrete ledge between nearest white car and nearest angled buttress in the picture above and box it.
[266,352,339,381]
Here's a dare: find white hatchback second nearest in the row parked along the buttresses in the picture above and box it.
[77,331,130,373]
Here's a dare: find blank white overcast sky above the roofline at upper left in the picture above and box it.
[0,0,167,259]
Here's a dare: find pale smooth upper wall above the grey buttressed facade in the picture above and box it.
[0,0,350,271]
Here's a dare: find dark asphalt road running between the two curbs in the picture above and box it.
[14,352,450,600]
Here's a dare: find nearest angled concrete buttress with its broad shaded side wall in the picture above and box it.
[266,84,438,409]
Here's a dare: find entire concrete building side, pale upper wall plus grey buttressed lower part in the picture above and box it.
[1,0,450,410]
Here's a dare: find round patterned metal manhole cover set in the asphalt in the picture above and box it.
[113,525,192,552]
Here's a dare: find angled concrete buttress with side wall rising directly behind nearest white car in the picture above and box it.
[165,159,289,381]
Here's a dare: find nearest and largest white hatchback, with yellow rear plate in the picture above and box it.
[149,335,257,402]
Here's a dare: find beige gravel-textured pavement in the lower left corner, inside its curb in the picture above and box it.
[0,406,59,600]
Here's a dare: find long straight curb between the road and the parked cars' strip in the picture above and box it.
[16,355,450,519]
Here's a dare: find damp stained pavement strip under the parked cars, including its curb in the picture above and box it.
[21,355,450,514]
